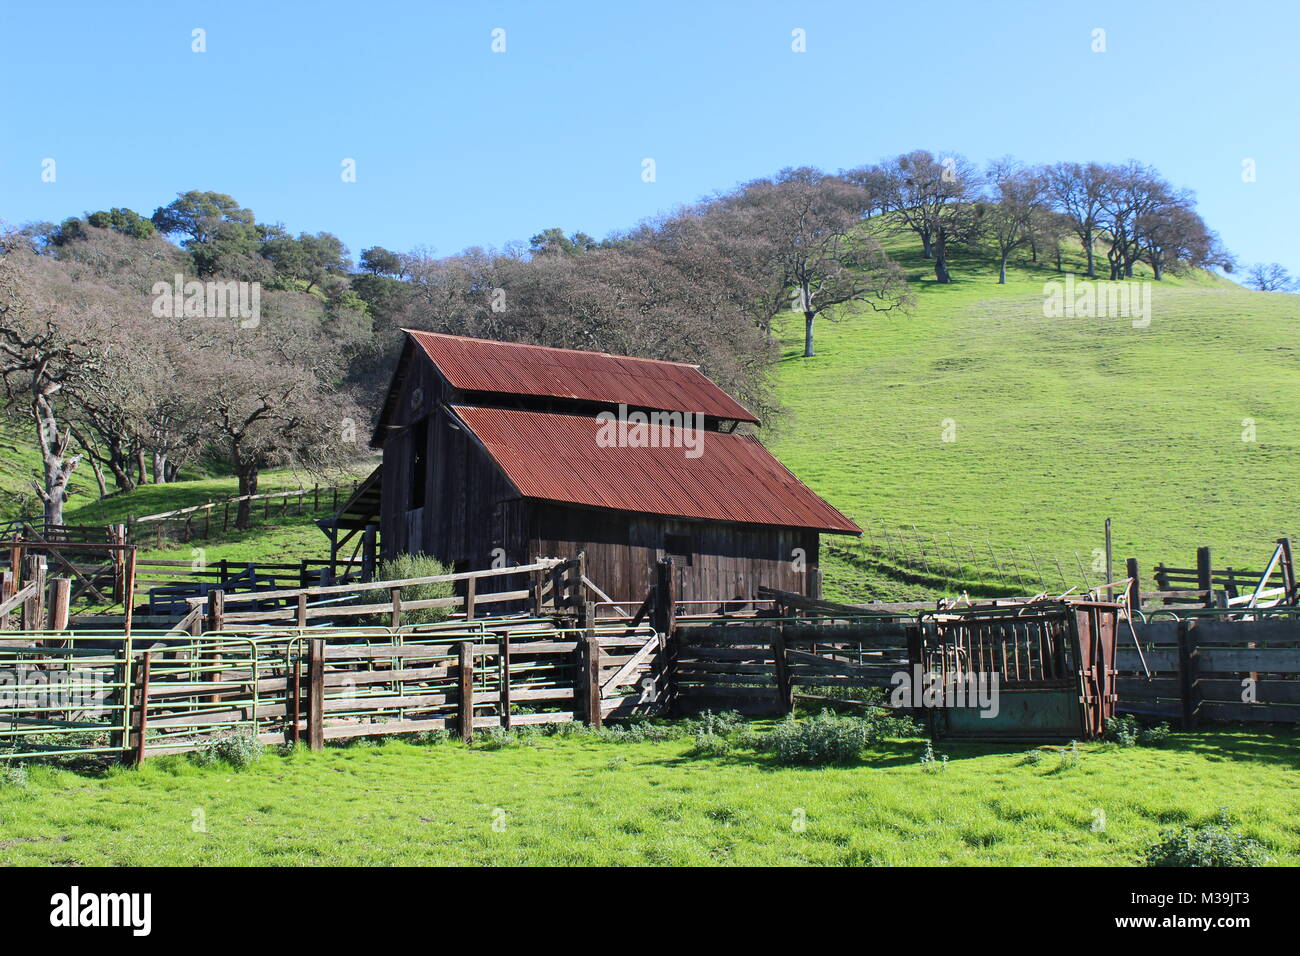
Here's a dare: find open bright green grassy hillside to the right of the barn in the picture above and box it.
[767,236,1300,598]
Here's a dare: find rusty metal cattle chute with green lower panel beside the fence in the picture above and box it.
[920,598,1123,740]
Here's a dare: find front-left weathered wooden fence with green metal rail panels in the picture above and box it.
[0,619,662,761]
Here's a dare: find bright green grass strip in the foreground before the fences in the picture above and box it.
[0,731,1300,866]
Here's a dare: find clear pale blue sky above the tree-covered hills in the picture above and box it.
[0,0,1300,269]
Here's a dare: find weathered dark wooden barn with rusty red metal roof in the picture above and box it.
[343,330,861,602]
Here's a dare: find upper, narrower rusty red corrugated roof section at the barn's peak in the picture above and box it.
[406,329,758,421]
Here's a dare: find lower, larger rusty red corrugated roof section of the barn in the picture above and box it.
[454,406,862,535]
